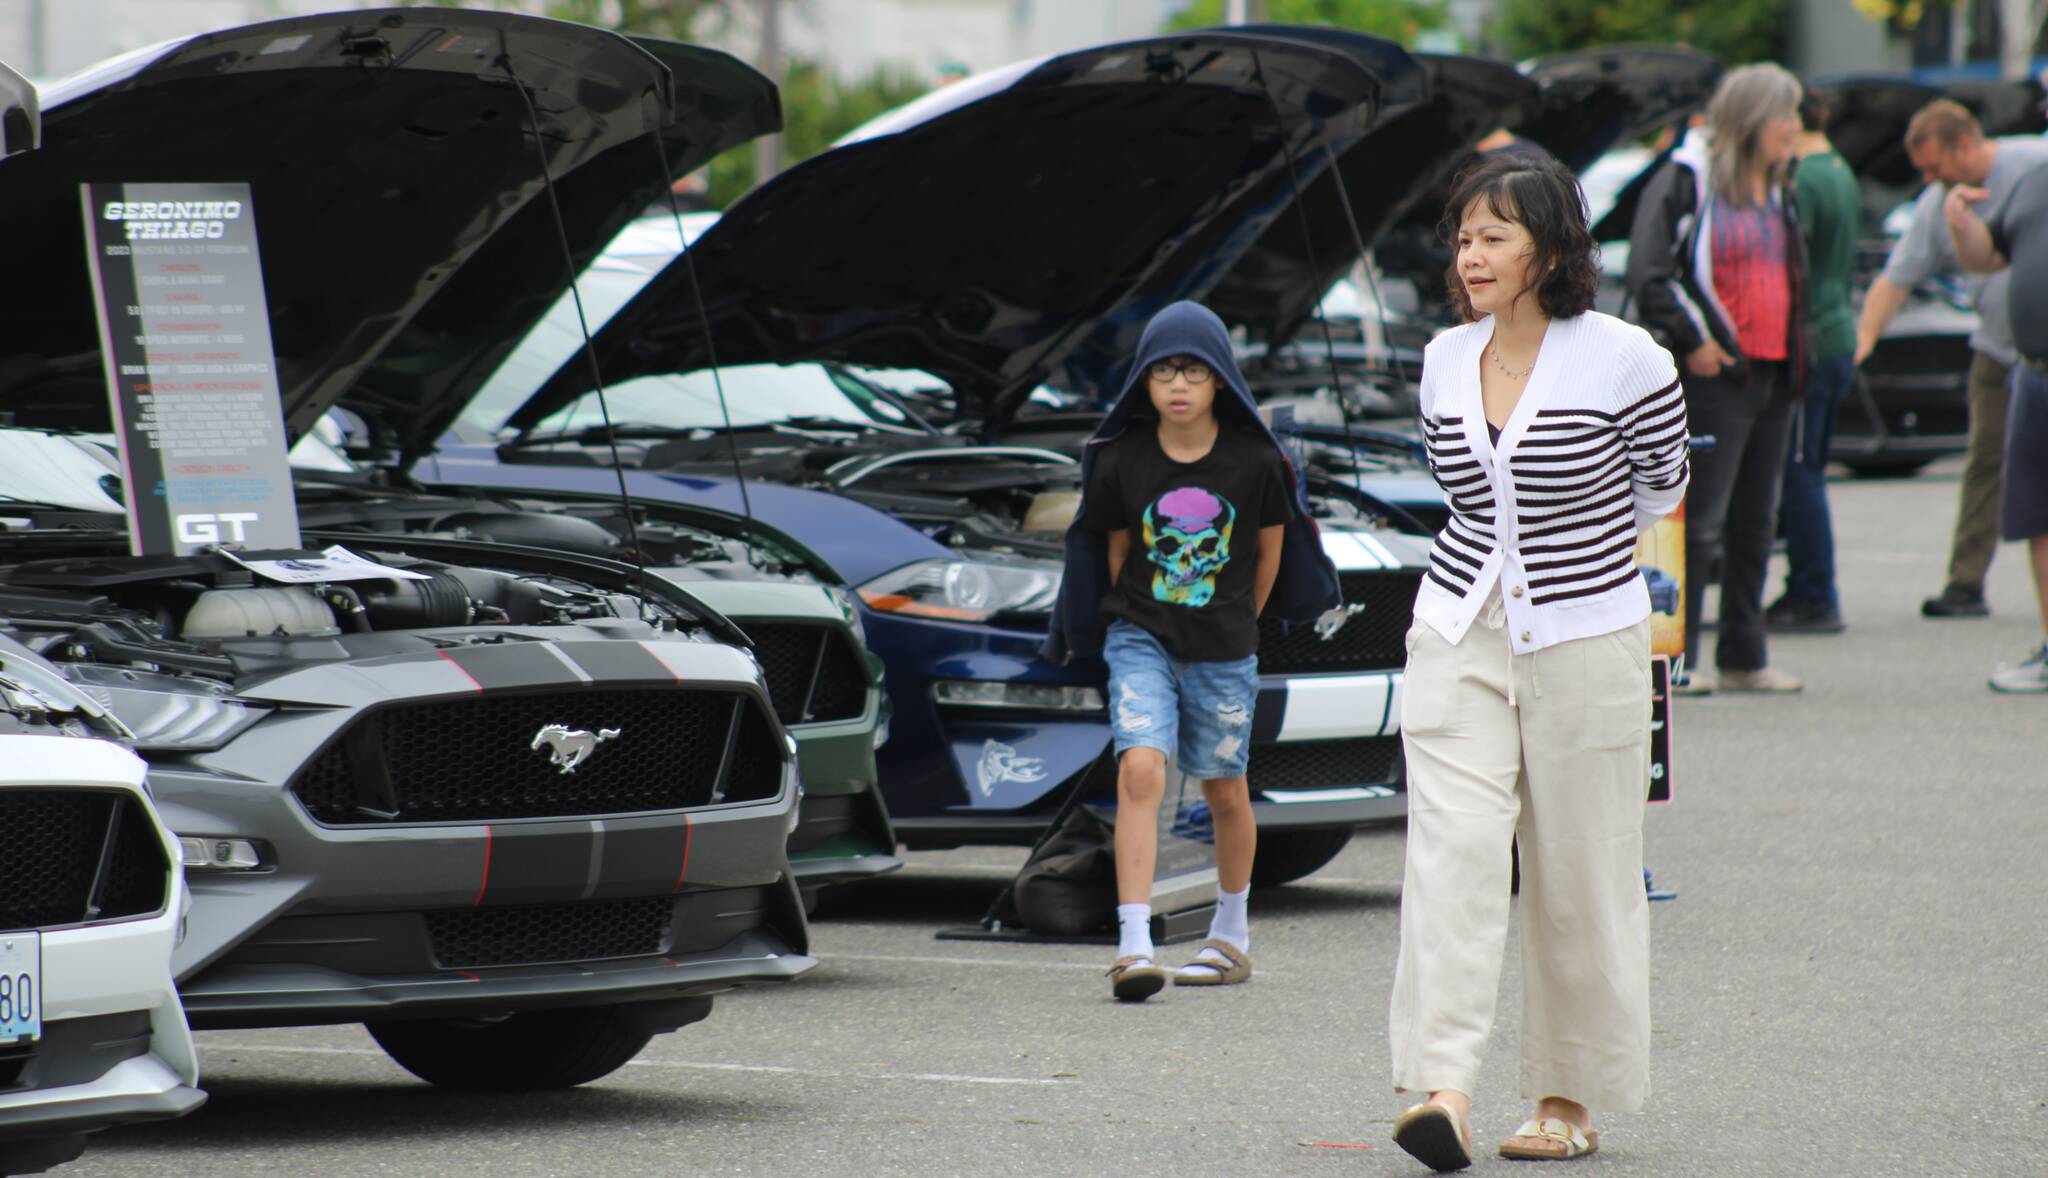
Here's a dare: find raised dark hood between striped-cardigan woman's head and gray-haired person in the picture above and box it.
[1522,45,1720,172]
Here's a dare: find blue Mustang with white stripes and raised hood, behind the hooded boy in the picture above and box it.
[422,31,1423,883]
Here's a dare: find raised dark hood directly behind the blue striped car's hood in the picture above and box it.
[1206,53,1536,346]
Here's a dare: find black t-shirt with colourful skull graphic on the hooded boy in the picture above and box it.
[1079,420,1294,662]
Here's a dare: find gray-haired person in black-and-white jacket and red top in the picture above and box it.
[1628,64,1806,695]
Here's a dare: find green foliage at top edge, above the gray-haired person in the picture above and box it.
[1491,0,1786,66]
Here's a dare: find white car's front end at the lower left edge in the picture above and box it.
[0,639,209,1174]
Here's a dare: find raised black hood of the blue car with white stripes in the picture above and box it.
[508,31,1407,442]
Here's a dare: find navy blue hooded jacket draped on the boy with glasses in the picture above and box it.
[1044,301,1343,664]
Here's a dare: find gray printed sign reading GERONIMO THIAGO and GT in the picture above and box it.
[80,184,299,555]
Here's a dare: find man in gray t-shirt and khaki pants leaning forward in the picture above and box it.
[1855,98,2048,617]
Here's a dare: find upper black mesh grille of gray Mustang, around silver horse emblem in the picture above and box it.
[291,688,782,826]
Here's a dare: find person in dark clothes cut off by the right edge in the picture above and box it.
[1942,164,2048,692]
